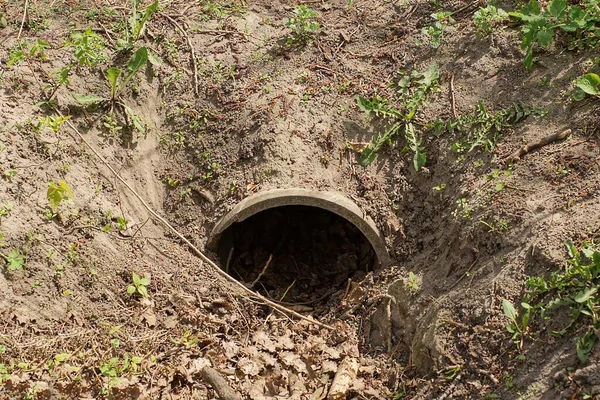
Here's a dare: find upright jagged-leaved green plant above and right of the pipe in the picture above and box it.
[357,64,439,171]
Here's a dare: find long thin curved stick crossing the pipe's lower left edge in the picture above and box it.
[54,108,335,330]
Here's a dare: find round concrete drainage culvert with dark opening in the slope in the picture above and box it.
[208,189,390,304]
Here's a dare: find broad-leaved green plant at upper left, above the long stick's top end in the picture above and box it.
[72,47,148,133]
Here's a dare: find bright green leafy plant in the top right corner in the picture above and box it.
[509,0,600,69]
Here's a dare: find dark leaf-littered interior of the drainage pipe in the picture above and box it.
[218,206,376,305]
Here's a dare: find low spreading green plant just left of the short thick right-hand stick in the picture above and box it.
[434,100,545,154]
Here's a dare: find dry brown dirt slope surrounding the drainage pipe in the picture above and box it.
[0,0,600,399]
